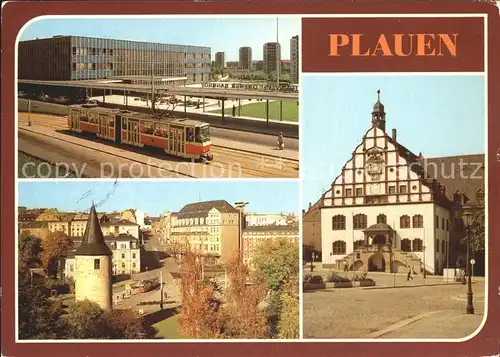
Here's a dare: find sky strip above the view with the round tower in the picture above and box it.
[18,180,300,216]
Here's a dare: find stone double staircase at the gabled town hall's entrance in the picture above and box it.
[335,244,434,275]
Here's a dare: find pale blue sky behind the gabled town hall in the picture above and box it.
[300,75,486,208]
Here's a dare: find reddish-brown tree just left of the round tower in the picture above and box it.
[42,231,74,279]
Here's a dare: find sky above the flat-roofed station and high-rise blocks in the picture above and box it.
[20,17,301,61]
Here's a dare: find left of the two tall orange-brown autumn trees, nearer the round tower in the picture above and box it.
[179,249,224,339]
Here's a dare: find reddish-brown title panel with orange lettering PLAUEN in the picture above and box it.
[302,17,484,72]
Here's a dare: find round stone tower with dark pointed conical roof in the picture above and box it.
[75,204,113,311]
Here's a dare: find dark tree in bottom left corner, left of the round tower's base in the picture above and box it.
[18,277,65,339]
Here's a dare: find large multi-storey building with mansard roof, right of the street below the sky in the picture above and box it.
[170,200,240,263]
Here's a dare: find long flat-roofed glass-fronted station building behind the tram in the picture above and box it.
[18,36,211,83]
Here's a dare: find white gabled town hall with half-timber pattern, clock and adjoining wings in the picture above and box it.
[303,91,485,275]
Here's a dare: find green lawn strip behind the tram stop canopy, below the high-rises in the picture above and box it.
[213,101,299,121]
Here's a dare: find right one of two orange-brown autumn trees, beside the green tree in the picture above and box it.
[224,253,268,338]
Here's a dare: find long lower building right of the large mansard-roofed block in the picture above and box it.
[243,225,299,267]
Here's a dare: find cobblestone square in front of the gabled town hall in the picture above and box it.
[303,274,485,339]
